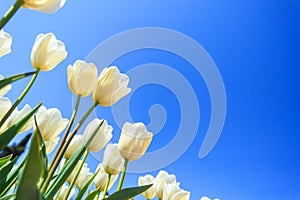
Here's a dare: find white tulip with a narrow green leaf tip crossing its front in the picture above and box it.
[83,118,113,152]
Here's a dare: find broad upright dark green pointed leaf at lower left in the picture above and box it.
[16,120,44,200]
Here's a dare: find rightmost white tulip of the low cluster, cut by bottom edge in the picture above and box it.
[162,183,190,200]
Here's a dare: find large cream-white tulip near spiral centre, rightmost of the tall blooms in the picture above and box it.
[118,122,153,161]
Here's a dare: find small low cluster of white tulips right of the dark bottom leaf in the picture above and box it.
[138,170,190,200]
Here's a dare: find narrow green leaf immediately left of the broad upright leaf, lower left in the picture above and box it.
[0,158,27,197]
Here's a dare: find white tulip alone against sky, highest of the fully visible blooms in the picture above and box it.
[31,33,67,71]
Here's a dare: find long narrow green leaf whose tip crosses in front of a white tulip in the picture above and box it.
[45,120,104,200]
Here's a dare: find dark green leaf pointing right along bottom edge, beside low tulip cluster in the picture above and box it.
[105,184,153,200]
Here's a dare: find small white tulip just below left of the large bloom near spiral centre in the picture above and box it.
[103,144,124,175]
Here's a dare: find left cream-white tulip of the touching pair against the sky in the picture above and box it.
[68,60,98,97]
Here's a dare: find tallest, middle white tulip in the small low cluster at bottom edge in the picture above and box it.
[154,170,176,199]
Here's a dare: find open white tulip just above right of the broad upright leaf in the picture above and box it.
[36,106,69,141]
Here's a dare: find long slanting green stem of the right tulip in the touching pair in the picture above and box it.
[41,103,98,193]
